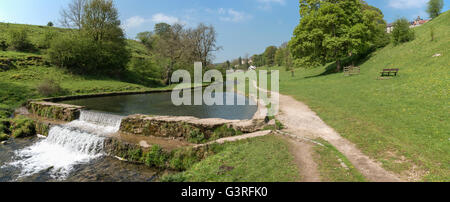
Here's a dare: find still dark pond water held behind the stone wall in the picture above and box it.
[62,92,257,120]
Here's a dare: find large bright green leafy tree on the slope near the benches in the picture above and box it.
[289,0,387,71]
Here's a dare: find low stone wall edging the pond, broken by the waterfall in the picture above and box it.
[27,85,267,142]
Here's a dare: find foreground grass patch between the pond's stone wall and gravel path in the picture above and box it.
[163,135,301,182]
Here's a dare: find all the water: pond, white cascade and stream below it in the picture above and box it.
[0,93,257,182]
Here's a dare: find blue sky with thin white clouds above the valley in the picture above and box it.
[0,0,450,62]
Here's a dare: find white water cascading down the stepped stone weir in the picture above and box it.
[6,110,122,179]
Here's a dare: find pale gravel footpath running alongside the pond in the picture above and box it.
[256,81,400,182]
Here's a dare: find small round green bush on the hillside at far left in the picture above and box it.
[7,29,33,51]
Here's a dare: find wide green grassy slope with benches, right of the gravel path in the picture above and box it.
[270,12,450,181]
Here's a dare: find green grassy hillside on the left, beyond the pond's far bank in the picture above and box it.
[0,23,165,117]
